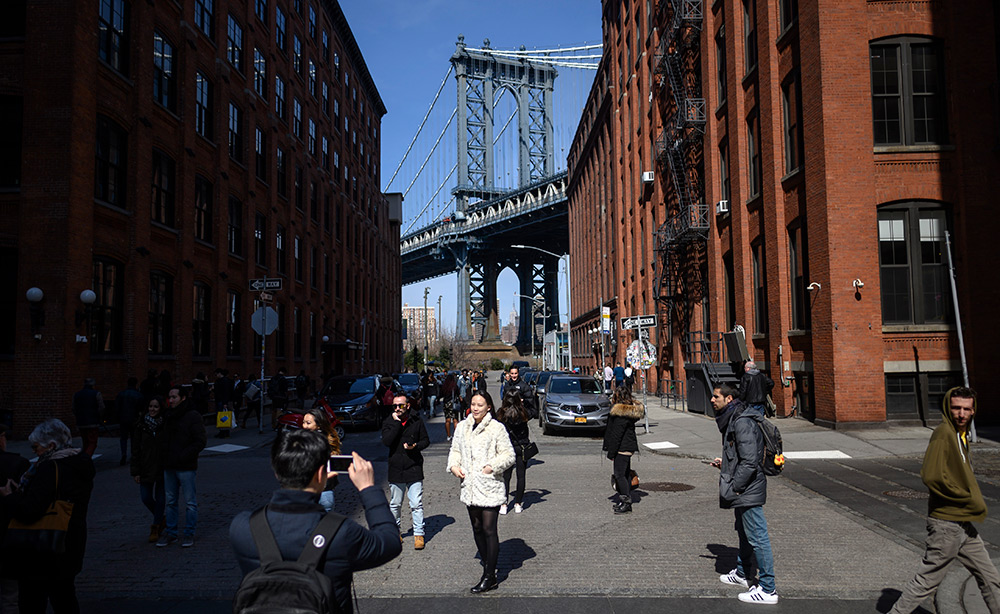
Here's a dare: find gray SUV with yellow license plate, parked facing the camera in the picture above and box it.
[538,374,611,435]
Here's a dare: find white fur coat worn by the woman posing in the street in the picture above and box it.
[448,414,515,507]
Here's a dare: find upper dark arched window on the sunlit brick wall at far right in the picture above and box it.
[871,38,948,146]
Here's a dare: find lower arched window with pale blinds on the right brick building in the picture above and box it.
[878,203,954,324]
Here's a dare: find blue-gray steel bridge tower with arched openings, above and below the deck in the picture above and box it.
[451,35,558,345]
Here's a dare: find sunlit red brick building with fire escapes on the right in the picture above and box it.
[570,0,1000,427]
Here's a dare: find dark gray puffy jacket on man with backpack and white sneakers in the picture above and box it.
[719,402,767,509]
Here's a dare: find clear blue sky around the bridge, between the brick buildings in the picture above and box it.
[341,0,601,330]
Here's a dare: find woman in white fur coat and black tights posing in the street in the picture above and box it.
[448,391,515,593]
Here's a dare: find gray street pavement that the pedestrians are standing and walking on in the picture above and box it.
[10,374,1000,614]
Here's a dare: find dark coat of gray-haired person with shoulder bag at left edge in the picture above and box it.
[0,452,96,578]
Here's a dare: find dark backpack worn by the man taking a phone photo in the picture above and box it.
[233,506,346,614]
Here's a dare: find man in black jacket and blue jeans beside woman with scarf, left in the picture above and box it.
[156,387,207,548]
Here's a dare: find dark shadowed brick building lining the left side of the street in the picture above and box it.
[0,0,401,433]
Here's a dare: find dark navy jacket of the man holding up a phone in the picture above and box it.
[229,486,402,614]
